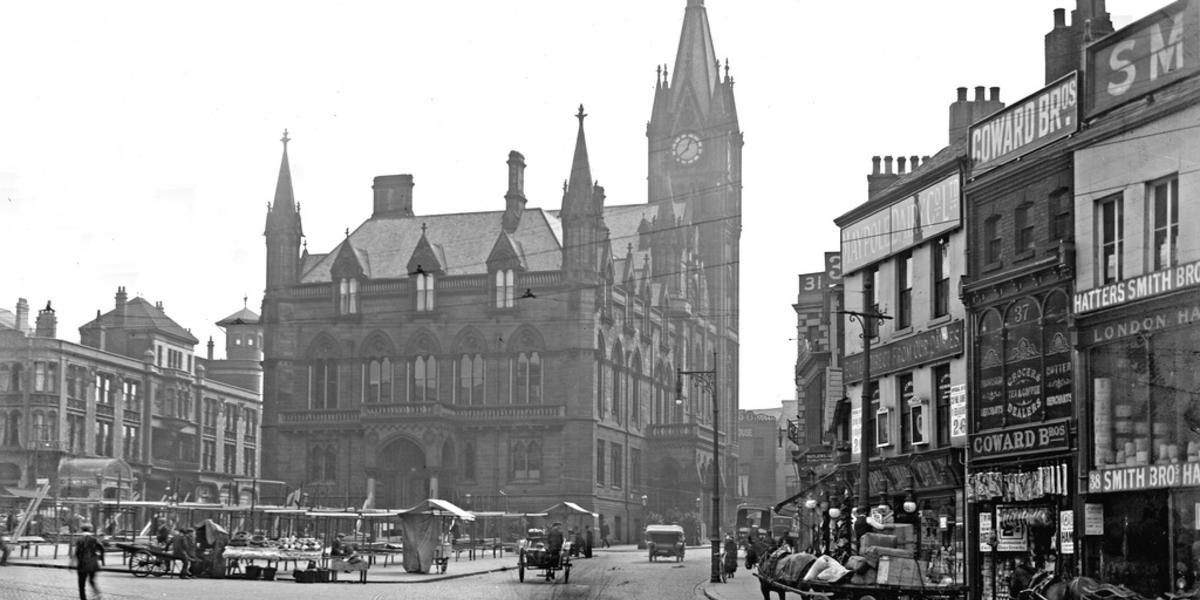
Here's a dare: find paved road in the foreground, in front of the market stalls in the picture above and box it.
[0,551,708,600]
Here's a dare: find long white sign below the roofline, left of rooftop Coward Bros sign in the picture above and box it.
[841,173,961,272]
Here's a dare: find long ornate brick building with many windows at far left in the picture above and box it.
[0,288,262,503]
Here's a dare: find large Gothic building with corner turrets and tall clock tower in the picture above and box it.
[263,0,742,540]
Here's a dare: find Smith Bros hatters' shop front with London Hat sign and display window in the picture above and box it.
[1079,286,1200,595]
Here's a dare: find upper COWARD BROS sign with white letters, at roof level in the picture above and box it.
[971,71,1079,174]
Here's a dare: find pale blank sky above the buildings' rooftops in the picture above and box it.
[0,0,1168,408]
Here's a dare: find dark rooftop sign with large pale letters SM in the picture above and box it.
[1087,0,1200,114]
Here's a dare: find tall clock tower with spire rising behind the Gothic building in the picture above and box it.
[646,0,742,333]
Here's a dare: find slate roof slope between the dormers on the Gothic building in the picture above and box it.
[300,209,563,283]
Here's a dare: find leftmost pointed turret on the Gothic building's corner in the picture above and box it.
[263,130,304,289]
